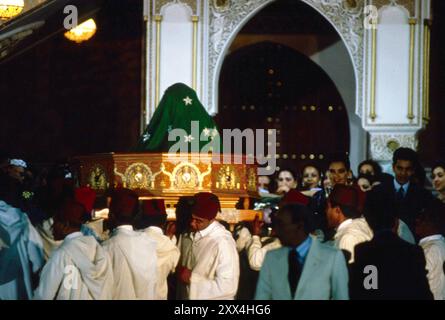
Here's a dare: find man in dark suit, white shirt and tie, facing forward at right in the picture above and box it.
[376,148,432,233]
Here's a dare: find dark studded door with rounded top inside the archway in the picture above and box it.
[216,41,350,175]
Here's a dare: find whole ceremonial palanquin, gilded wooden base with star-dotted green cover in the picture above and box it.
[74,83,258,223]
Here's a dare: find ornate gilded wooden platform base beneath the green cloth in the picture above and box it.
[73,153,260,224]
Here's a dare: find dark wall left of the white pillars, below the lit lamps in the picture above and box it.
[0,0,143,162]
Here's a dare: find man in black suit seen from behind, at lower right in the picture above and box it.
[350,190,433,300]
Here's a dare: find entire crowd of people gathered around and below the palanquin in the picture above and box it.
[0,148,445,300]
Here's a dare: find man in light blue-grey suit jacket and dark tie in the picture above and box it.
[255,204,349,300]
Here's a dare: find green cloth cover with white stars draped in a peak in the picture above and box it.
[135,83,221,152]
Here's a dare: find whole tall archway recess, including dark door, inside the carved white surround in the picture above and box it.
[216,0,358,175]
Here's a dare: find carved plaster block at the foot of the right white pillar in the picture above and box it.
[370,133,418,161]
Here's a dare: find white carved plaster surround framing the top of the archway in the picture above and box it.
[207,0,364,116]
